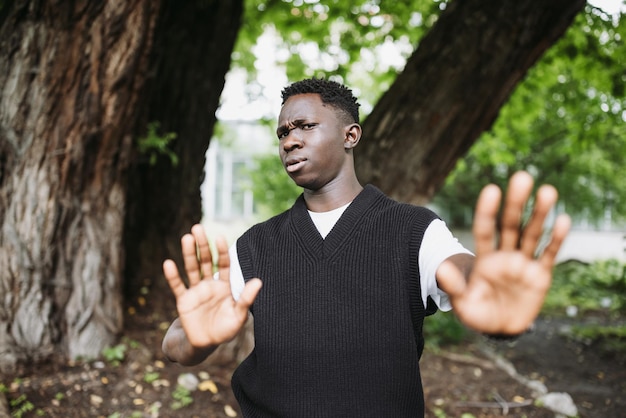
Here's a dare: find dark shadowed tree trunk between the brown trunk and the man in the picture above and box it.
[124,0,243,309]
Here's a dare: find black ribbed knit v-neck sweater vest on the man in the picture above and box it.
[232,186,436,418]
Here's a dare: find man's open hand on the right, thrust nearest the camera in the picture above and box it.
[437,172,570,335]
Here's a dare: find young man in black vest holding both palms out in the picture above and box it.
[163,79,569,417]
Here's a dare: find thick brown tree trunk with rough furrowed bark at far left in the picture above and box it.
[0,0,157,368]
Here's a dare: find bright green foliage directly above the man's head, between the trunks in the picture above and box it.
[233,0,446,112]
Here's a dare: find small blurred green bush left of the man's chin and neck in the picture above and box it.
[249,154,302,218]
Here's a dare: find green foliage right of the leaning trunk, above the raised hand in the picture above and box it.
[435,6,626,226]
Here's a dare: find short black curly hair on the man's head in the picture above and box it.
[282,78,360,123]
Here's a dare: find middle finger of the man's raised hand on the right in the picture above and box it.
[500,171,533,250]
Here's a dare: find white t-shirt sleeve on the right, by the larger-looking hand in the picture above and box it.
[416,219,472,312]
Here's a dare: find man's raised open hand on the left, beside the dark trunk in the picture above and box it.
[163,225,261,348]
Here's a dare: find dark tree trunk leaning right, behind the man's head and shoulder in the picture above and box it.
[356,0,586,204]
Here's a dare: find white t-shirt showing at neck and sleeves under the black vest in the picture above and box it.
[229,203,472,311]
